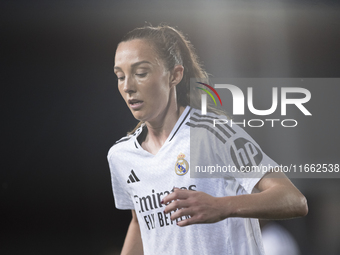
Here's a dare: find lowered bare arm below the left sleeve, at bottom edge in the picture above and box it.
[121,211,143,255]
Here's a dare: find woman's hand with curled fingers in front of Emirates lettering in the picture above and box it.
[162,188,225,227]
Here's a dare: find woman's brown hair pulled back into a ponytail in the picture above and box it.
[117,25,223,134]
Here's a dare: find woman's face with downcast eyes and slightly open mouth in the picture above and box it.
[114,39,174,121]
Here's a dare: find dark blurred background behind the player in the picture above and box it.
[0,0,340,255]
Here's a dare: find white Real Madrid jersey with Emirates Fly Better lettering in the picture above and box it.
[108,107,276,255]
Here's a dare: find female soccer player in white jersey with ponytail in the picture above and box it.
[108,26,308,255]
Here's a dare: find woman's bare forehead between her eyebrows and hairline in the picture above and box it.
[115,39,158,66]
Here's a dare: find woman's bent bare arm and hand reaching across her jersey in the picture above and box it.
[162,173,308,227]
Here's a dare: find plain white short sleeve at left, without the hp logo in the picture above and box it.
[108,153,134,210]
